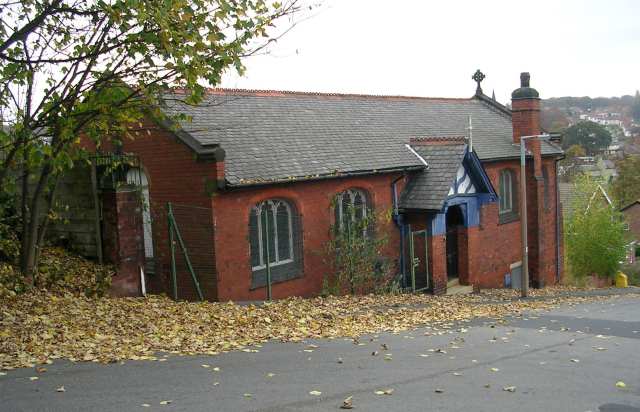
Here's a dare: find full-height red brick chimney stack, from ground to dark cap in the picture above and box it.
[511,73,546,286]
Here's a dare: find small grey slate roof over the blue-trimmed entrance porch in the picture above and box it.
[400,142,467,210]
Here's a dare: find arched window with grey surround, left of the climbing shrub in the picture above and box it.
[249,199,301,288]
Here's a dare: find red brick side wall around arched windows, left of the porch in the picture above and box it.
[213,174,401,300]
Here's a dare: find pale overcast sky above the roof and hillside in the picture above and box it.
[222,0,640,103]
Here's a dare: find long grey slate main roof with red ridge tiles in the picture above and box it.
[164,89,562,185]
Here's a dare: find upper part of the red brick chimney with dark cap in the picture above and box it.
[511,73,542,176]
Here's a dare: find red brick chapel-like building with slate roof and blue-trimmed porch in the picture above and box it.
[80,73,563,301]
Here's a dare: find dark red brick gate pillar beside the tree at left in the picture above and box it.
[102,188,144,296]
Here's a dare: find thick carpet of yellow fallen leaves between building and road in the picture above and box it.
[0,276,620,369]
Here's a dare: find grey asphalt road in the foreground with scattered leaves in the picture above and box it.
[0,297,640,412]
